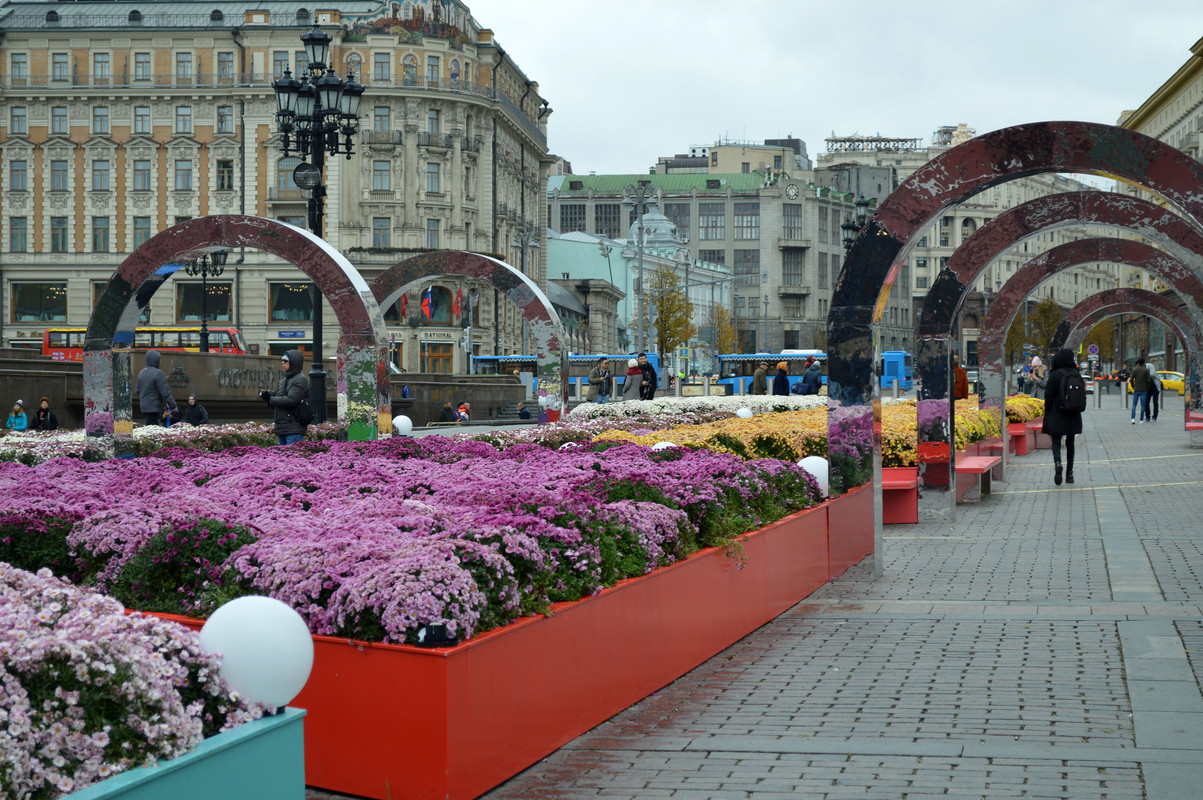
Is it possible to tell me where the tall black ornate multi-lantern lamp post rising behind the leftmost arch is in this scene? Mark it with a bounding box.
[273,25,363,422]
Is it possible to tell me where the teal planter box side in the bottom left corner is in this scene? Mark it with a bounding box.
[64,709,306,800]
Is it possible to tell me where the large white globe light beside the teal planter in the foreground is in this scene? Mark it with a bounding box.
[201,597,313,706]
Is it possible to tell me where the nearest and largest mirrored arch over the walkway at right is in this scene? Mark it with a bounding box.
[828,122,1203,538]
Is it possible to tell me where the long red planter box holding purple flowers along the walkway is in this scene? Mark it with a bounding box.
[157,486,873,800]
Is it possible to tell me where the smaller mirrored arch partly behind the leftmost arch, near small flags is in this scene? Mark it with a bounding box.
[372,250,568,410]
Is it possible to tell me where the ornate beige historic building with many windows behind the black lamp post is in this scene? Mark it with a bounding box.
[0,0,553,372]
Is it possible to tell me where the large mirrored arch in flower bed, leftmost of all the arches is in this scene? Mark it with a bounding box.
[83,214,391,455]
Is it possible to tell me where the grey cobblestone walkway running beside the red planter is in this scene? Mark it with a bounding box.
[469,395,1203,800]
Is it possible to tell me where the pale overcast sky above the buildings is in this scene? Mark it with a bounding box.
[466,0,1203,173]
